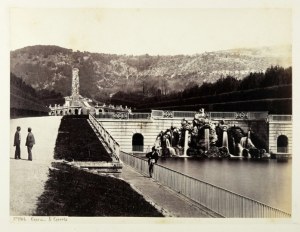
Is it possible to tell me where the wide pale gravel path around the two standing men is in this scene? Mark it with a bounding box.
[10,117,61,216]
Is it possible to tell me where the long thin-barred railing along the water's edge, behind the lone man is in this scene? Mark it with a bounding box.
[120,152,291,218]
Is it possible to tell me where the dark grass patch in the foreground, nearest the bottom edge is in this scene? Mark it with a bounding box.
[35,163,163,217]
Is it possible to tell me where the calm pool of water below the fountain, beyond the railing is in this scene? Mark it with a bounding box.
[158,158,292,212]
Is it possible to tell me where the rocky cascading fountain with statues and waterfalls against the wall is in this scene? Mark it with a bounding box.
[156,110,268,158]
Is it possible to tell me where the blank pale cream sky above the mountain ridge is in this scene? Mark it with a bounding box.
[9,7,292,55]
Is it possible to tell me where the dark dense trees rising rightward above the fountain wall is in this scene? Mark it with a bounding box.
[111,66,292,113]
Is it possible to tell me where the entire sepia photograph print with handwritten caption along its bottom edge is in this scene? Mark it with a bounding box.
[3,1,298,230]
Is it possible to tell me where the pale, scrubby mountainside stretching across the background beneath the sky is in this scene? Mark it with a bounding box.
[10,45,291,101]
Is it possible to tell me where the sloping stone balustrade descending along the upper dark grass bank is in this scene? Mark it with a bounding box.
[89,114,120,160]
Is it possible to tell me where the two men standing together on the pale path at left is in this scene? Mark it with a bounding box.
[14,126,35,161]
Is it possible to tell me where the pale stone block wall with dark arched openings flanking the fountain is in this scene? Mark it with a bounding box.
[98,115,292,153]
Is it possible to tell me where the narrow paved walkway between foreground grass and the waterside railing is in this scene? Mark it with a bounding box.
[121,165,217,218]
